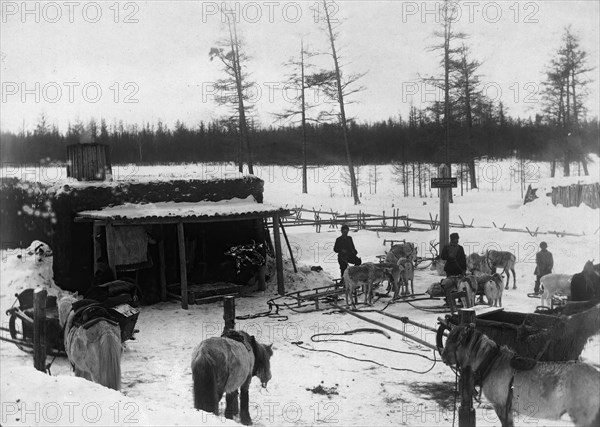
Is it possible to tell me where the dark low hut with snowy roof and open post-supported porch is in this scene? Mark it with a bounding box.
[2,170,289,307]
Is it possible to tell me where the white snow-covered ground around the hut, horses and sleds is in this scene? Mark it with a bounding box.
[0,158,600,426]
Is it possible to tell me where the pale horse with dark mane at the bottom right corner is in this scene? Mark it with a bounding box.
[441,325,600,427]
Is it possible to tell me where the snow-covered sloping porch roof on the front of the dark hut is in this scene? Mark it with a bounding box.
[77,196,289,221]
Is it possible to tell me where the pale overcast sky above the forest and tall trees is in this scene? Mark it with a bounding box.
[0,1,600,131]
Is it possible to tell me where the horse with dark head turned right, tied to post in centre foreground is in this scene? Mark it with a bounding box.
[192,331,273,425]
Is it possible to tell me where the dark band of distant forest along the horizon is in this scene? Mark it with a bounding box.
[0,111,600,164]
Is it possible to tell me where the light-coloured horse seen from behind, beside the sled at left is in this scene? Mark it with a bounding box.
[58,294,122,390]
